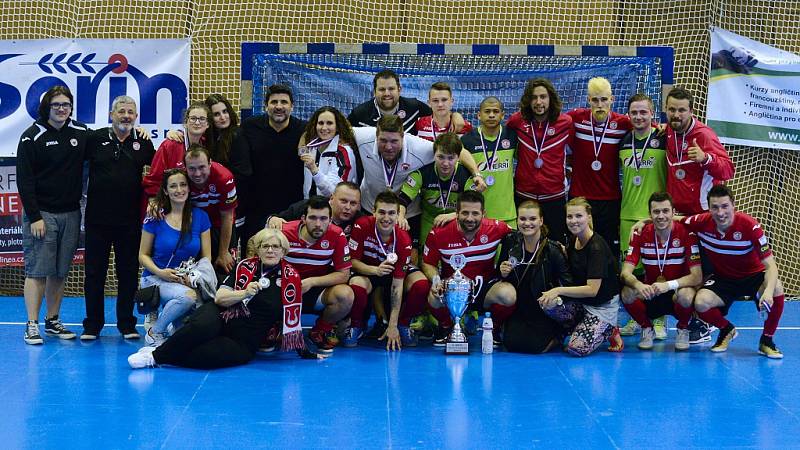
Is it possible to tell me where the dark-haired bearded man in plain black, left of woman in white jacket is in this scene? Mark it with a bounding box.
[234,84,306,246]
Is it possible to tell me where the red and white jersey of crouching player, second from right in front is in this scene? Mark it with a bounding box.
[625,222,700,284]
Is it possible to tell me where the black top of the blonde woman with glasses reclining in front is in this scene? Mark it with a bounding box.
[222,264,283,351]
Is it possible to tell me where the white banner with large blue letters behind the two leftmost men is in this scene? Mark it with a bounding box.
[0,39,191,157]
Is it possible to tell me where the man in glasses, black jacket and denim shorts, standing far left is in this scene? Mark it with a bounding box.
[17,86,87,344]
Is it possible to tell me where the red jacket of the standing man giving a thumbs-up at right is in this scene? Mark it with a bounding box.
[667,118,734,215]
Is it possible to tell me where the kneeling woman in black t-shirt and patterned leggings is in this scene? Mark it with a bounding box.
[539,197,624,356]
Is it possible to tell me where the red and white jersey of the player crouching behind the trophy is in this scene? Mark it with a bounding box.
[423,219,512,282]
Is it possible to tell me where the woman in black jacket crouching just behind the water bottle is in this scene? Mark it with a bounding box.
[498,200,572,353]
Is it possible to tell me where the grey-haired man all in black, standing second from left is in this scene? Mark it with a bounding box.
[80,95,155,341]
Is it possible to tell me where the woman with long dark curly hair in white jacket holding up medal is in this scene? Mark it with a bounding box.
[299,106,361,198]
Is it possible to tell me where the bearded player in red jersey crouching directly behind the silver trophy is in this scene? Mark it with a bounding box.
[422,191,516,346]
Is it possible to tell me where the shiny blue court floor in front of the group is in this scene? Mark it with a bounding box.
[0,297,800,449]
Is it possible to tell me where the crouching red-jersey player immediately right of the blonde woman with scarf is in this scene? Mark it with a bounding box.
[282,195,353,353]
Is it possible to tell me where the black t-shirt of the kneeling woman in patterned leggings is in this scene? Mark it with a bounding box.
[567,233,619,306]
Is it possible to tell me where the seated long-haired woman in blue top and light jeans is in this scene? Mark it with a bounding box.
[139,169,211,347]
